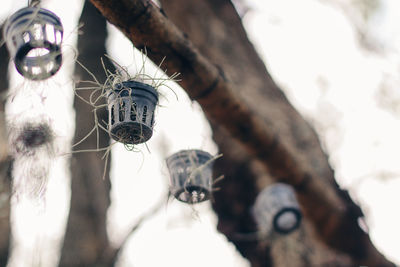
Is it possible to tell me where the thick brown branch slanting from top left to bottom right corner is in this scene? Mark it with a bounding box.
[91,0,394,266]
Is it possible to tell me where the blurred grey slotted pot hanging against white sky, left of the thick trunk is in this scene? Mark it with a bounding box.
[166,150,213,204]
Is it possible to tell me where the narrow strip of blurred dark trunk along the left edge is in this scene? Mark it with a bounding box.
[0,24,12,266]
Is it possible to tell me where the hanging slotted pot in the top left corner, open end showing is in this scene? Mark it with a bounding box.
[3,7,63,80]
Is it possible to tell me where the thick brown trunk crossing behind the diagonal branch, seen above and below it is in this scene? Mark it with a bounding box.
[161,0,351,266]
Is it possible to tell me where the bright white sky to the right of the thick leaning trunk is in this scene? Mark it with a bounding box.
[245,0,400,263]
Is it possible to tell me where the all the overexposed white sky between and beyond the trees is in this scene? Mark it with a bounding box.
[0,0,400,267]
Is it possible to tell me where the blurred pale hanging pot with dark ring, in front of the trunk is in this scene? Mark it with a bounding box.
[253,183,302,234]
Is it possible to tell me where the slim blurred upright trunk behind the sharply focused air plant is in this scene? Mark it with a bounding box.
[59,1,113,267]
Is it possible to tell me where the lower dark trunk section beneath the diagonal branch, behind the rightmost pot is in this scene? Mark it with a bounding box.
[212,124,354,267]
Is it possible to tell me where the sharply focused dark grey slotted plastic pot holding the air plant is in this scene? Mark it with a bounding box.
[108,81,158,145]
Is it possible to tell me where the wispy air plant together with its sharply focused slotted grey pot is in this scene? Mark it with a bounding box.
[73,52,179,178]
